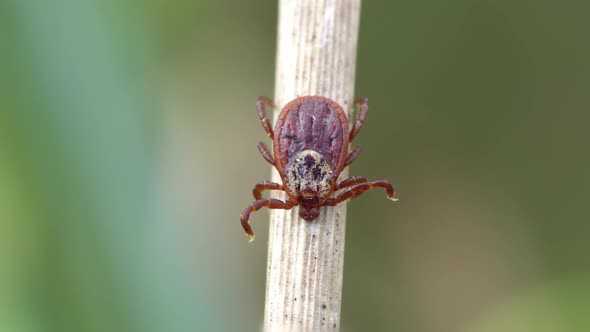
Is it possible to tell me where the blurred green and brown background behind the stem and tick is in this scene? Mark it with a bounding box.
[0,0,590,332]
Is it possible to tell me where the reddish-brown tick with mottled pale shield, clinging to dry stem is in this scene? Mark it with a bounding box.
[240,96,397,241]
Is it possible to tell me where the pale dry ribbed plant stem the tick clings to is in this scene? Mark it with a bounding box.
[264,0,360,331]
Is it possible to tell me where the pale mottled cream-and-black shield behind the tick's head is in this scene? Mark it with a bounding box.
[285,150,334,200]
